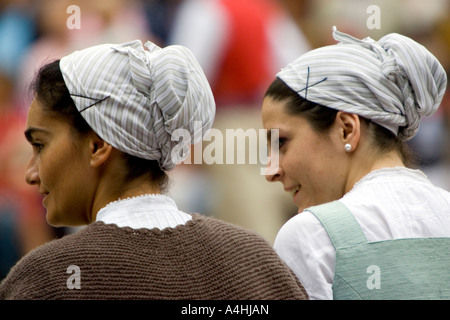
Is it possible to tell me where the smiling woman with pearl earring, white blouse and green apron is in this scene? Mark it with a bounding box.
[262,28,450,299]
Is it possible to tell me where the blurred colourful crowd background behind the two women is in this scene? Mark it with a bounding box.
[0,0,450,280]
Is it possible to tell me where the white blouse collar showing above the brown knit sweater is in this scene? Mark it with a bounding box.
[96,194,192,230]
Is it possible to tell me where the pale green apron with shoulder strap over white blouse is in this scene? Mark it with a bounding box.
[307,201,450,300]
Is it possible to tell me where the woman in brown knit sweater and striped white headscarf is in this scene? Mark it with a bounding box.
[0,41,307,299]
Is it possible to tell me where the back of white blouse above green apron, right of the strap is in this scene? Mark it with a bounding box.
[340,168,450,242]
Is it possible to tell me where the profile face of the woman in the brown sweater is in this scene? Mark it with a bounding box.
[25,99,92,226]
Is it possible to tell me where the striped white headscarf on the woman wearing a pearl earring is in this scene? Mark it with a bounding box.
[277,27,447,140]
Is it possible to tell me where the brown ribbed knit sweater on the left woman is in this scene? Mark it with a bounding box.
[0,215,307,300]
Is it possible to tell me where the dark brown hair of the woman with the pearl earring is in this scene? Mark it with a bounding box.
[264,78,417,167]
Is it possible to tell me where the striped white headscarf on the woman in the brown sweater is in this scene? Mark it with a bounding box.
[60,40,215,170]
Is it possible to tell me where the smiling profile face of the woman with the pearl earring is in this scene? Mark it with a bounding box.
[262,97,346,212]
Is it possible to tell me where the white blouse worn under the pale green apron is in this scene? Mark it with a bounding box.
[274,167,450,300]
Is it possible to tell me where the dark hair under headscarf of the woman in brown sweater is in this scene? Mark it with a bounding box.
[31,60,169,192]
